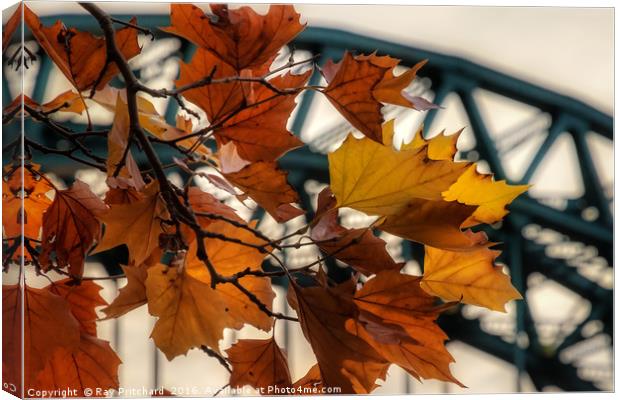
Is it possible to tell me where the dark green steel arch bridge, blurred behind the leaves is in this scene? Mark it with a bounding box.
[3,15,613,391]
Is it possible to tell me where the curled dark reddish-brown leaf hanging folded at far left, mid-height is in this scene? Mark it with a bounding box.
[39,180,107,278]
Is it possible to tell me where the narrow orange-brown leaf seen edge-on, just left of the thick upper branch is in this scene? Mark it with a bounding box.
[106,95,145,191]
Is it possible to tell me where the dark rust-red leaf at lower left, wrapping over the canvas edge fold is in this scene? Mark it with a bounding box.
[2,285,80,384]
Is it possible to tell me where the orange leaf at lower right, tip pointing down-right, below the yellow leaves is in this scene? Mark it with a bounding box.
[347,271,462,385]
